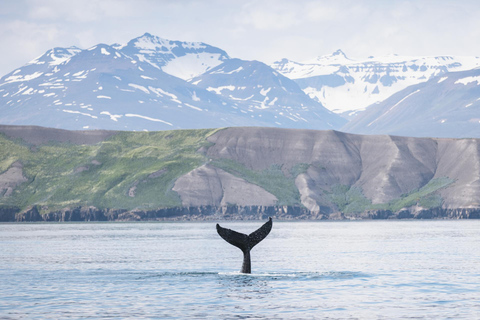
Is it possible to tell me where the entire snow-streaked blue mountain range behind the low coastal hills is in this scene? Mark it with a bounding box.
[0,33,480,137]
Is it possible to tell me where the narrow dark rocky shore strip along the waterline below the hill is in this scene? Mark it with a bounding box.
[0,206,480,222]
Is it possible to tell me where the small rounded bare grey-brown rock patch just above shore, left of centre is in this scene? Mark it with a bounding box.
[173,164,278,207]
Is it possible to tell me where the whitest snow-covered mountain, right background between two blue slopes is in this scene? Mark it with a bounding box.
[271,50,480,118]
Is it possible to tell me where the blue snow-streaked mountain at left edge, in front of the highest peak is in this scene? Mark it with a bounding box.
[0,44,247,130]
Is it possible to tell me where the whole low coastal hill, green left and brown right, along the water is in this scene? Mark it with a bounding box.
[0,126,480,221]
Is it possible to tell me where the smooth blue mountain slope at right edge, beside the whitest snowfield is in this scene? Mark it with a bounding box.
[342,69,480,138]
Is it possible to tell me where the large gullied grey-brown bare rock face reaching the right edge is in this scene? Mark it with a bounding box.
[206,128,480,212]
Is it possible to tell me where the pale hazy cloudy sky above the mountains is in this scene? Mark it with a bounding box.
[0,0,480,76]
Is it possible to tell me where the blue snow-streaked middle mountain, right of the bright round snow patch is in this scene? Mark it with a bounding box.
[191,59,345,128]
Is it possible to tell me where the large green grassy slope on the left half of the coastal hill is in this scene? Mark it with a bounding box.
[0,130,217,209]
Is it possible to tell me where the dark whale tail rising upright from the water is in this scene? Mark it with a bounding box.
[217,218,273,273]
